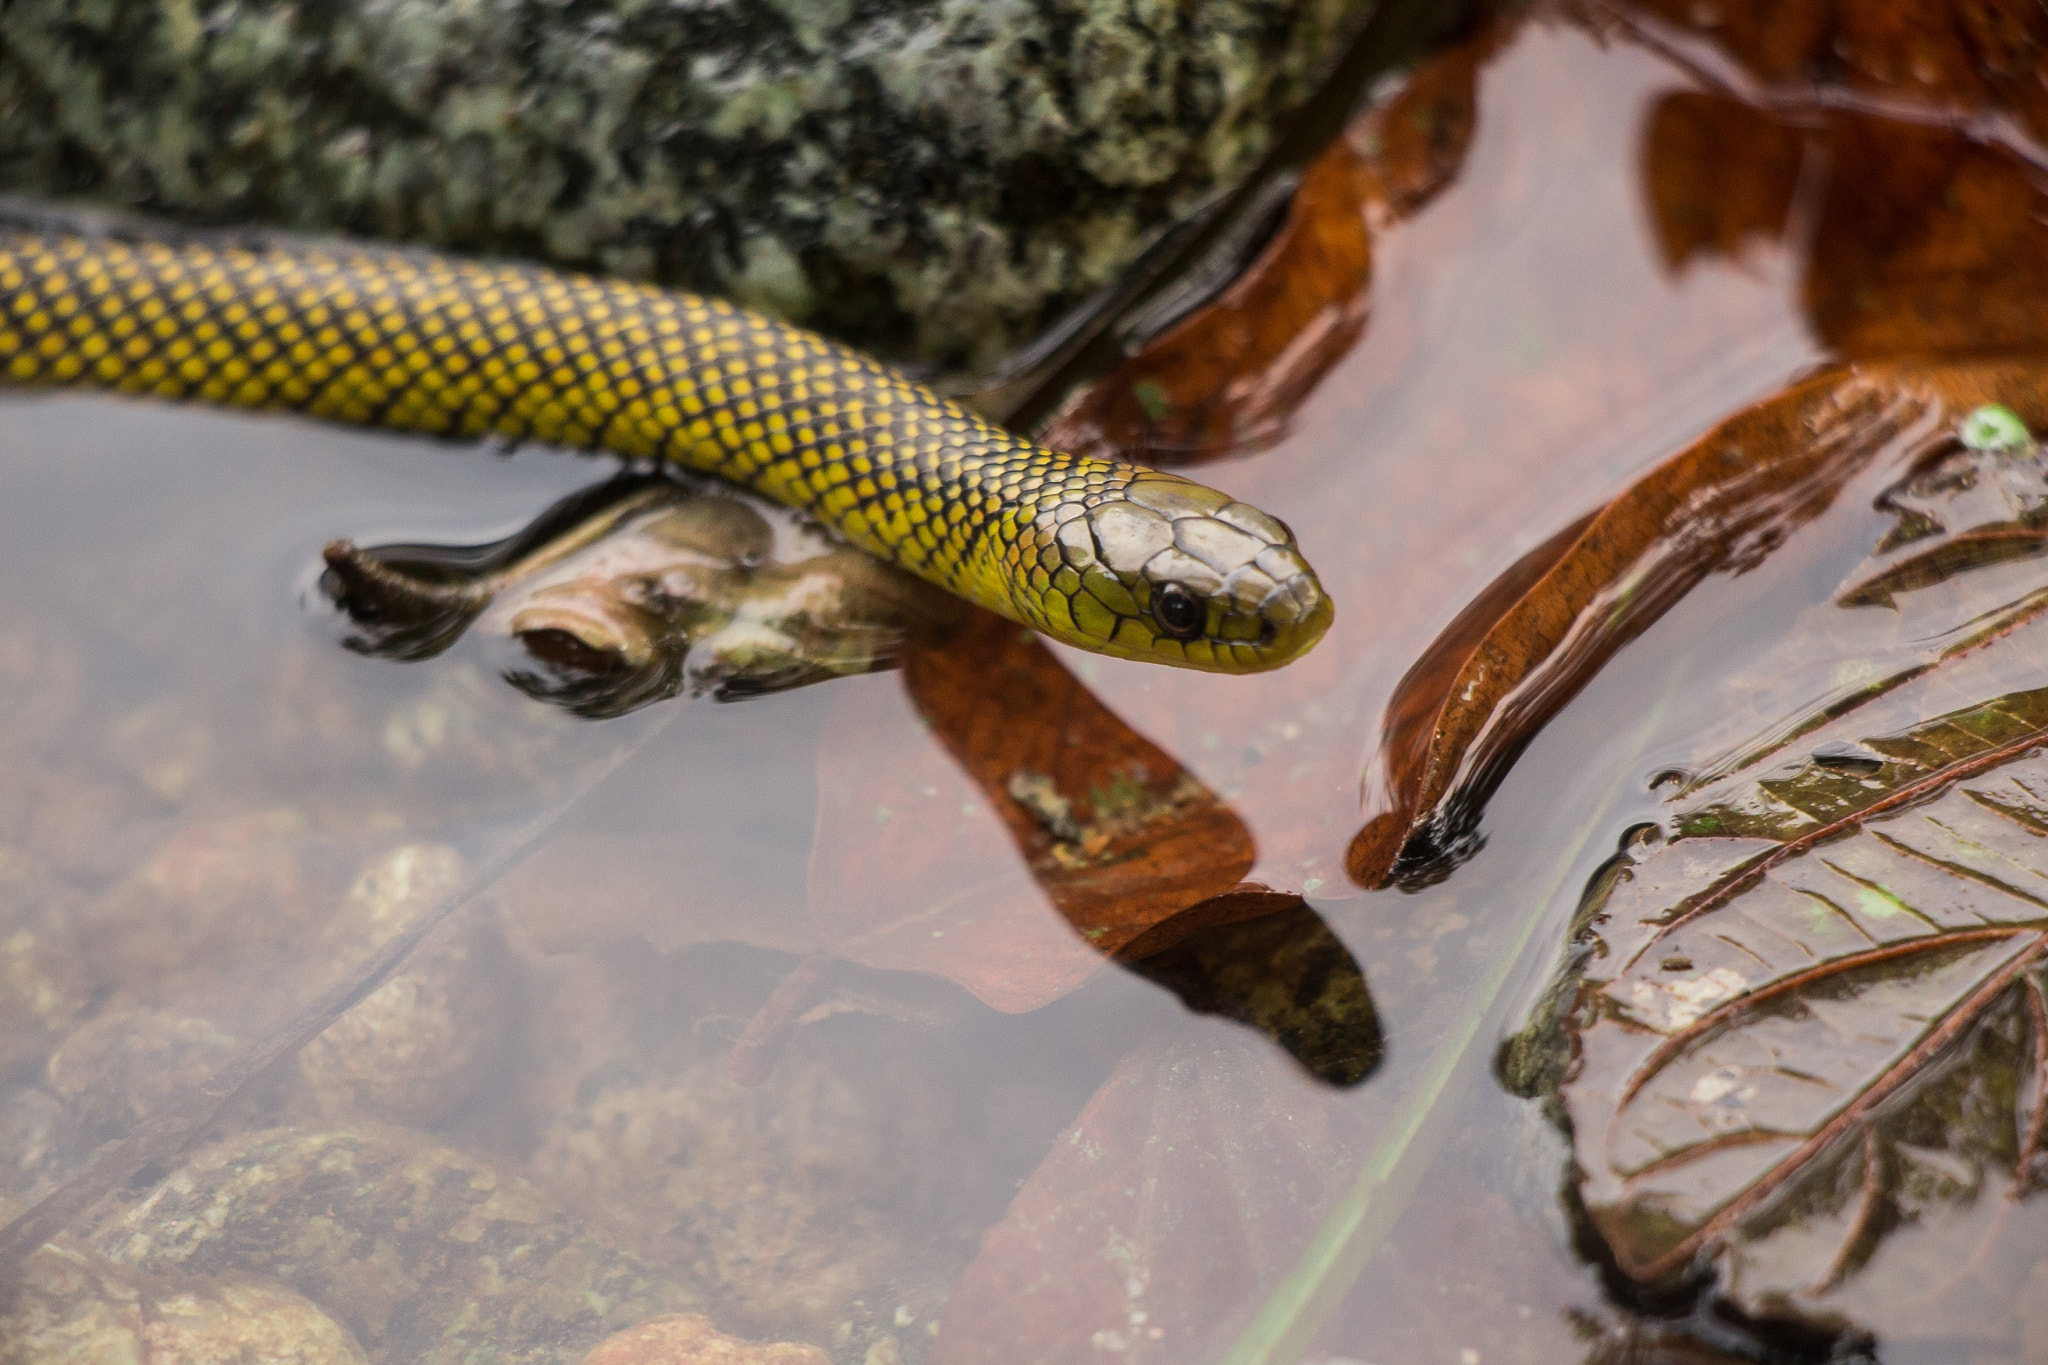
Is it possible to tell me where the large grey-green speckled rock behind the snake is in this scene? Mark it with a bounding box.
[0,0,1374,362]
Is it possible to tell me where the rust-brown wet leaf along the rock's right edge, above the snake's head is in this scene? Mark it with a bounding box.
[1042,27,1505,465]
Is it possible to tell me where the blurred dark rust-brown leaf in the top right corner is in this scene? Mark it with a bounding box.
[1642,92,2048,358]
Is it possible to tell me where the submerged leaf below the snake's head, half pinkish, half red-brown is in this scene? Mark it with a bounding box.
[811,614,1298,1011]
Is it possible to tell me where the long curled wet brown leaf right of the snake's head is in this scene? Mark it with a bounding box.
[1348,362,2048,886]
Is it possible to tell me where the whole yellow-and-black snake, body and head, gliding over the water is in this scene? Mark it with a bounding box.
[0,217,1333,673]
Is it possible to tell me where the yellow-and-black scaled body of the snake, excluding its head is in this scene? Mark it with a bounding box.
[0,225,1138,655]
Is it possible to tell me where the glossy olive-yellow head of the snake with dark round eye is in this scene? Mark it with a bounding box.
[1032,471,1331,673]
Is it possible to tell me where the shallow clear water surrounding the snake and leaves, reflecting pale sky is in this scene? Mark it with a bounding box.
[0,10,2034,1365]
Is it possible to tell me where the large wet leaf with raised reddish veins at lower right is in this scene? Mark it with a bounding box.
[1523,620,2048,1308]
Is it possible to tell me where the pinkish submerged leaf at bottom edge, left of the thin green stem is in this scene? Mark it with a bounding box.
[932,1033,1356,1365]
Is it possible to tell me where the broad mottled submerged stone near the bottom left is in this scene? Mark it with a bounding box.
[92,1130,702,1365]
